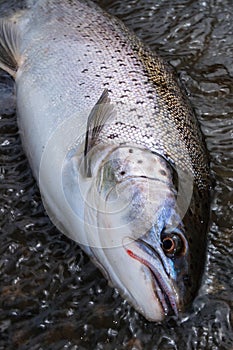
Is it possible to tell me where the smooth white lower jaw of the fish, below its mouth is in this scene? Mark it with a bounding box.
[92,243,166,322]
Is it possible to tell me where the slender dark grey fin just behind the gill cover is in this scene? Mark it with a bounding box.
[84,89,115,177]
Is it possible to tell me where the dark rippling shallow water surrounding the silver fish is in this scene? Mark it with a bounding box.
[0,0,233,350]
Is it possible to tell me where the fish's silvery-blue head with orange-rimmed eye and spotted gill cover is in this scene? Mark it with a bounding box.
[85,146,208,321]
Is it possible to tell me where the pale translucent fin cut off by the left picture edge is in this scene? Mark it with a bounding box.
[0,18,20,77]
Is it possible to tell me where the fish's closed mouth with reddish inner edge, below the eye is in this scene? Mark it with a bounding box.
[124,239,179,316]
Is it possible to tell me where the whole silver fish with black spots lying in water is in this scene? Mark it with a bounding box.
[0,0,211,322]
